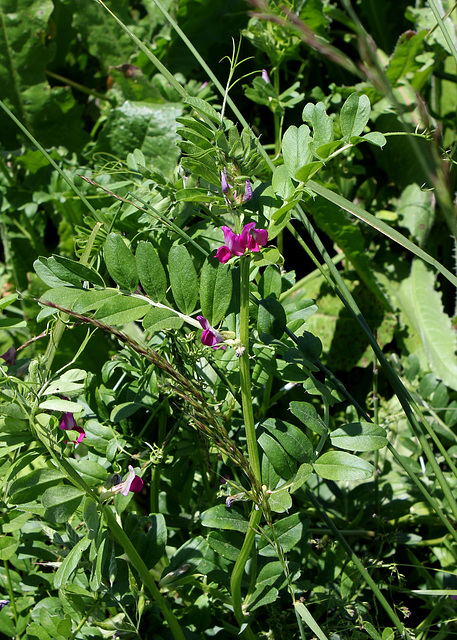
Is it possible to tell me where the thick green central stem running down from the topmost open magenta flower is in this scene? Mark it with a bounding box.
[230,255,262,640]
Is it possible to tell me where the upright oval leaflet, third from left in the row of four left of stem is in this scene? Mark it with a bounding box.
[168,244,198,315]
